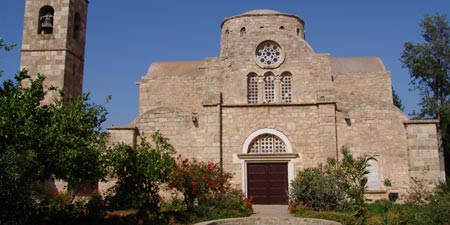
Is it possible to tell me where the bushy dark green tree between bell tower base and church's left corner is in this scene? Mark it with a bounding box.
[44,94,108,190]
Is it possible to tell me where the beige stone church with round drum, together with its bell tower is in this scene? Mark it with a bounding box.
[21,0,443,204]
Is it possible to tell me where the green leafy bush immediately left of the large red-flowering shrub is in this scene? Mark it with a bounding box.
[108,131,175,210]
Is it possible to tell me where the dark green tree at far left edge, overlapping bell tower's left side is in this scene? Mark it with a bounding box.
[0,71,48,224]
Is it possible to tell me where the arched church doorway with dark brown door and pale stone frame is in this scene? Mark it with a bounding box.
[239,129,298,204]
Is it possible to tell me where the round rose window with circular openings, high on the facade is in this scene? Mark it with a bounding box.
[256,41,283,68]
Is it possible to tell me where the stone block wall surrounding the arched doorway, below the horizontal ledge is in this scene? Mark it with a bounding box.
[223,105,335,187]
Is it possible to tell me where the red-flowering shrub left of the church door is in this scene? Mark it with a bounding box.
[169,155,231,210]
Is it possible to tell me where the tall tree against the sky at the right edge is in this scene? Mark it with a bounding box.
[401,15,450,174]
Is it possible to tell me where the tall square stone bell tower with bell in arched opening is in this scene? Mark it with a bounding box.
[20,0,89,104]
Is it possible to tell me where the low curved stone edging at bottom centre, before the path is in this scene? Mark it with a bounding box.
[195,217,342,225]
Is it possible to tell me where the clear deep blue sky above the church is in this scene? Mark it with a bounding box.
[0,0,450,126]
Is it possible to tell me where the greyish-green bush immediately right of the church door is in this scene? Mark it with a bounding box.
[289,149,369,224]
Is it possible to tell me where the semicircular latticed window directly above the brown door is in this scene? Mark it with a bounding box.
[248,133,286,154]
